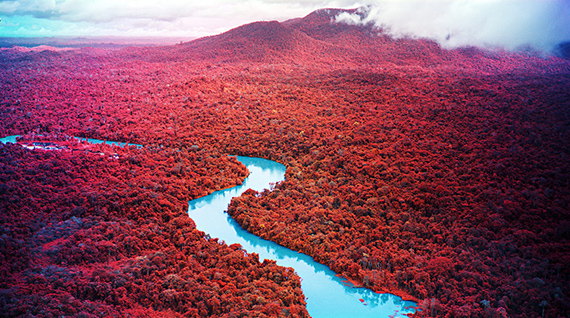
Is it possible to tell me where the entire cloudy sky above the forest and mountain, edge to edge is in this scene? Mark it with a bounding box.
[0,0,570,50]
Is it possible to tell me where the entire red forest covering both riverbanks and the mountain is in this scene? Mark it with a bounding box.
[0,10,570,317]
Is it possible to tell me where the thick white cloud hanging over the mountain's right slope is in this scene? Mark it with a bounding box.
[336,0,570,50]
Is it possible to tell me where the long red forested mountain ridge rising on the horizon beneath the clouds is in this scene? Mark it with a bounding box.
[134,9,564,69]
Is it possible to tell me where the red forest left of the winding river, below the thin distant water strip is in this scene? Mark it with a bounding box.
[0,141,308,317]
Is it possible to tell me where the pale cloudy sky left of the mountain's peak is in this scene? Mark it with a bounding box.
[0,0,360,37]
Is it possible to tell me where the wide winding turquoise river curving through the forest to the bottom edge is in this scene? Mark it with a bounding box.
[188,156,416,318]
